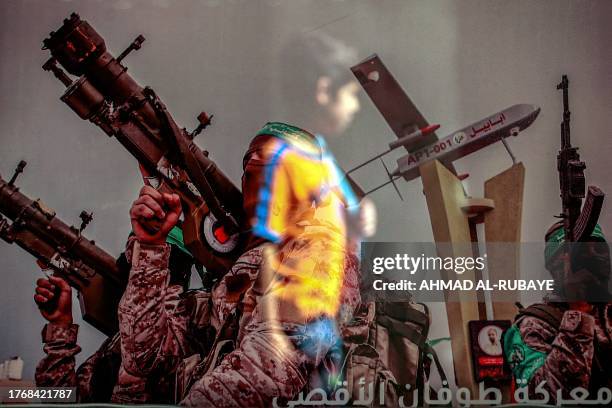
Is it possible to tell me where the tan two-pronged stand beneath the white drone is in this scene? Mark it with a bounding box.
[419,161,525,396]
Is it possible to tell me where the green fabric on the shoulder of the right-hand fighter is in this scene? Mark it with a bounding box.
[503,324,547,384]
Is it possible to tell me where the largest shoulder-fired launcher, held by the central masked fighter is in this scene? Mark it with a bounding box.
[43,13,248,273]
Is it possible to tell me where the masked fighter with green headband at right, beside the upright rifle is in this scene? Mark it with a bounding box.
[504,223,612,403]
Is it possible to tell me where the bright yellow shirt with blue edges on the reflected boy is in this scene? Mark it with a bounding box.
[247,124,356,321]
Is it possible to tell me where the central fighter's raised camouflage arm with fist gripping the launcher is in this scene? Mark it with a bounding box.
[119,186,188,376]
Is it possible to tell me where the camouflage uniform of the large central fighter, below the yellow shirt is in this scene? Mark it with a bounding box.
[119,237,360,407]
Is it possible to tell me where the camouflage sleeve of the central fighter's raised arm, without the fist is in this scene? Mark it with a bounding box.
[118,241,188,377]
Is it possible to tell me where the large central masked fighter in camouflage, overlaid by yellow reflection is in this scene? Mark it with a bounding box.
[115,31,371,406]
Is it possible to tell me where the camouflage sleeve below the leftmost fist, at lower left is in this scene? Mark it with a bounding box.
[34,323,81,387]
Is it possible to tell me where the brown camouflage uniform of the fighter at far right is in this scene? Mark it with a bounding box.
[506,303,612,403]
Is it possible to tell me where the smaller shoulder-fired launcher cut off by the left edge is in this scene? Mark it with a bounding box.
[0,161,128,336]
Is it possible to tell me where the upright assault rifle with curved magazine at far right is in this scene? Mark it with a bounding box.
[557,75,604,242]
